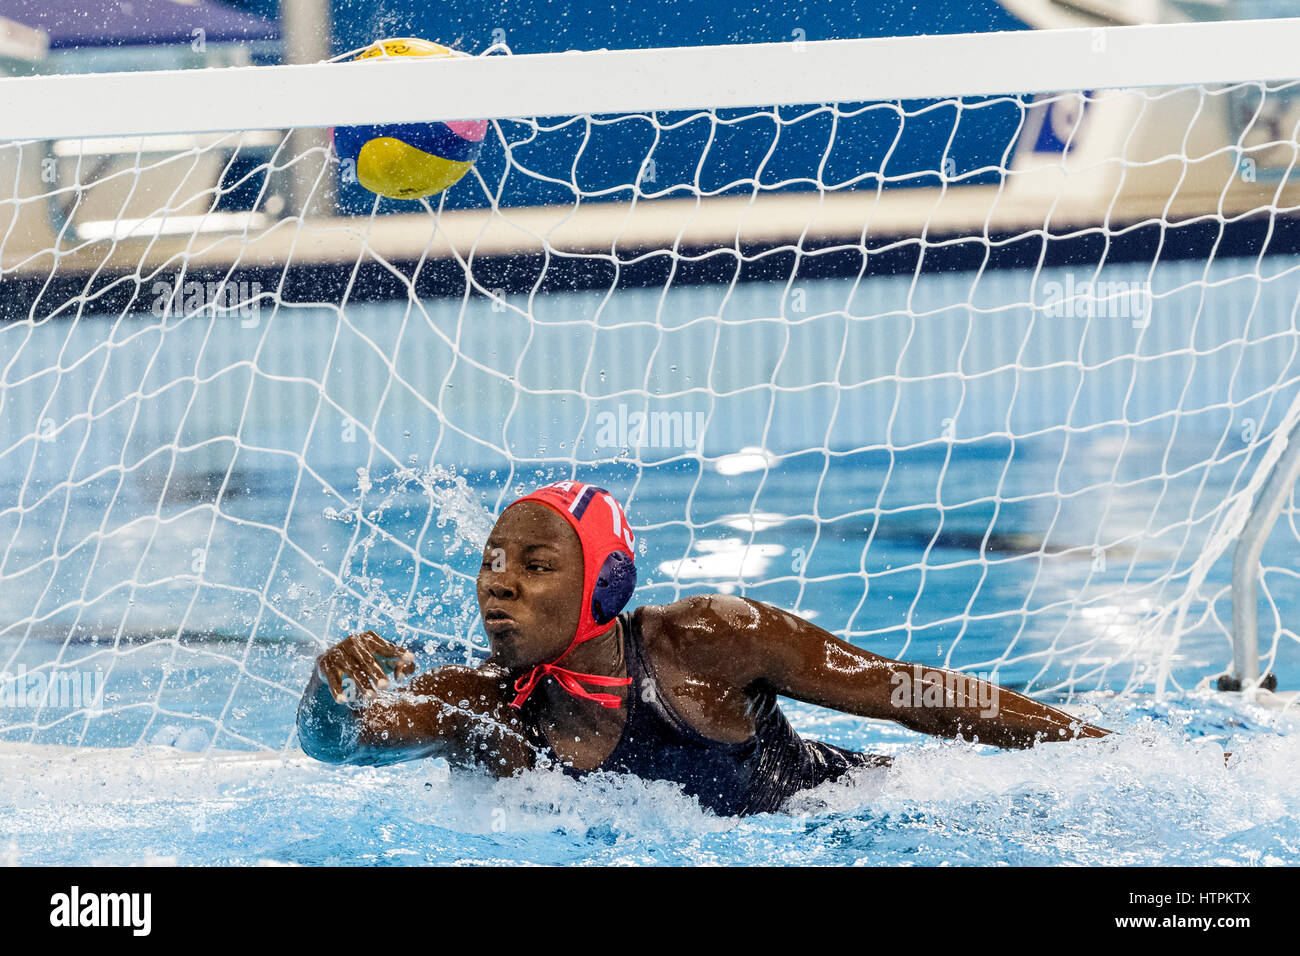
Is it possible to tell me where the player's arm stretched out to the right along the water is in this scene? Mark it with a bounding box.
[664,594,1110,748]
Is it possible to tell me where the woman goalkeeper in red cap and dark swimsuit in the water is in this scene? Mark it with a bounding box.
[298,481,1109,814]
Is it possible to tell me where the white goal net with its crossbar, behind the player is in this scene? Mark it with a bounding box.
[0,21,1300,749]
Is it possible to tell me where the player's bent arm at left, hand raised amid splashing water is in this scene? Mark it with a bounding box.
[298,631,536,775]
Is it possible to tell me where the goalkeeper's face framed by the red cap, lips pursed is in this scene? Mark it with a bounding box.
[478,501,582,670]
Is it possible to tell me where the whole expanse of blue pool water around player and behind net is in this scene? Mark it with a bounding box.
[0,260,1300,865]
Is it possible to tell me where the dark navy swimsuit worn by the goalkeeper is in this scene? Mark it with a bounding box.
[521,611,888,816]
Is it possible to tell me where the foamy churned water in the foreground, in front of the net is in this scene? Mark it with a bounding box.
[0,696,1300,865]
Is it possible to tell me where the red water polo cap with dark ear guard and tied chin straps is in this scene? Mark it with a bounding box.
[507,481,637,708]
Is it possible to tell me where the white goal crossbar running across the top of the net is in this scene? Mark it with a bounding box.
[0,17,1300,140]
